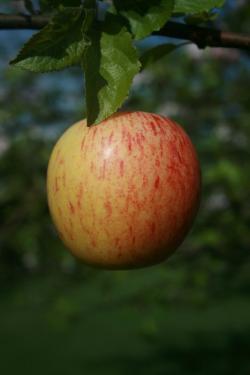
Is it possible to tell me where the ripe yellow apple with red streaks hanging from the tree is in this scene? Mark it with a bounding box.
[47,112,201,269]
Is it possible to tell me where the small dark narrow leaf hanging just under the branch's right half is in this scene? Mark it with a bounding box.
[140,43,180,70]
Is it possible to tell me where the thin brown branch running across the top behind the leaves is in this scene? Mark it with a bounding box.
[0,14,250,51]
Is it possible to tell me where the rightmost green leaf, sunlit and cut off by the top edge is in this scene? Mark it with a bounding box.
[174,0,225,14]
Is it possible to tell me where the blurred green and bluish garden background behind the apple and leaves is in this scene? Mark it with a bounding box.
[0,1,250,375]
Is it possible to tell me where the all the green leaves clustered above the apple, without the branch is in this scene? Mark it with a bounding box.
[9,0,224,125]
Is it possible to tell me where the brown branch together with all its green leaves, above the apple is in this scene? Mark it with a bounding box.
[0,0,250,125]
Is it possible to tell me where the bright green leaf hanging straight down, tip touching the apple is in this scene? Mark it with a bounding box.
[83,14,140,125]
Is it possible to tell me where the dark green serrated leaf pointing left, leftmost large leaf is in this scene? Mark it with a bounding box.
[11,8,91,73]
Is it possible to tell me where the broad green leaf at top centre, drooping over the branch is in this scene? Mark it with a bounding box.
[113,0,174,39]
